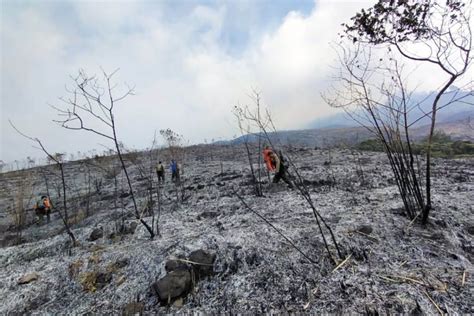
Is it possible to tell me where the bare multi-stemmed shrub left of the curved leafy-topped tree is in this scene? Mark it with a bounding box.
[323,45,465,223]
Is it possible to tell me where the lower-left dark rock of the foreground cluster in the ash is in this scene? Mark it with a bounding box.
[152,270,192,304]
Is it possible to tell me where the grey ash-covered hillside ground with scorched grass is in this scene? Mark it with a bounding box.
[0,146,474,314]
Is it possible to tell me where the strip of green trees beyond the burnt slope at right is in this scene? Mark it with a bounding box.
[356,132,474,158]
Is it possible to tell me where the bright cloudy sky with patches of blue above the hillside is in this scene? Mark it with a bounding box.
[0,0,470,161]
